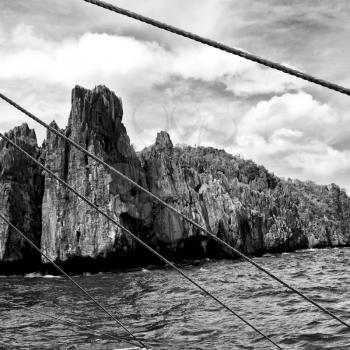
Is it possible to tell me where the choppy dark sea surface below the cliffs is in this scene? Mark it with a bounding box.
[0,248,350,350]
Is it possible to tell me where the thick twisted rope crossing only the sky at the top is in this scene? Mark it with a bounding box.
[83,0,350,96]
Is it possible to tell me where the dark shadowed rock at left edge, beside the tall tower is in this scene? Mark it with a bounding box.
[0,124,43,272]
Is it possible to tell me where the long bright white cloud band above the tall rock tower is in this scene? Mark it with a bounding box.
[0,25,301,95]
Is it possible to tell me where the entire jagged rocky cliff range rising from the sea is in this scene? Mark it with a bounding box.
[0,86,350,270]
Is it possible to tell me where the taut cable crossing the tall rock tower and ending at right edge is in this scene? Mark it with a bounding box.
[0,93,350,328]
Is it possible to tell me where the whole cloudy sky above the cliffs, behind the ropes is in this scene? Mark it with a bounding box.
[0,0,350,191]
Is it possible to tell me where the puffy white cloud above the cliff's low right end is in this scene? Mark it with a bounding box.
[230,92,350,189]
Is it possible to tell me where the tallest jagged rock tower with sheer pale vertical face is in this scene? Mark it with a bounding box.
[42,86,151,268]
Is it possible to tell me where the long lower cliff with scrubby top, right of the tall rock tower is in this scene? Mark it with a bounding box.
[140,132,350,256]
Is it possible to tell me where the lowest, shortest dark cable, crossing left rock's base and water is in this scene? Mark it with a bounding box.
[0,212,147,348]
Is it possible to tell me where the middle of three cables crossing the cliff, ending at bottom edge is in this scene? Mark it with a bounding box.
[0,132,282,349]
